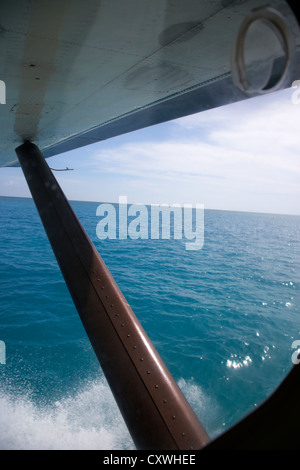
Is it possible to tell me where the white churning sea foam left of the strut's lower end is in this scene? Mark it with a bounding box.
[0,379,135,450]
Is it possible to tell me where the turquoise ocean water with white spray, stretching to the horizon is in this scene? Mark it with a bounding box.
[0,197,300,450]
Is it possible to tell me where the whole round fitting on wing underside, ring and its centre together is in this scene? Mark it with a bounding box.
[231,7,294,95]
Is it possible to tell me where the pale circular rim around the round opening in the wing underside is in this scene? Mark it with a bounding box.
[231,7,294,95]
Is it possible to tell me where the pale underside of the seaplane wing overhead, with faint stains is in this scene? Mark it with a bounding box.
[0,0,300,166]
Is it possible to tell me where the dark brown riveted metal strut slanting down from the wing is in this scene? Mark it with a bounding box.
[16,142,209,450]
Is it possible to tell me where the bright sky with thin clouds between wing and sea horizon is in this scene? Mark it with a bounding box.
[0,88,300,215]
